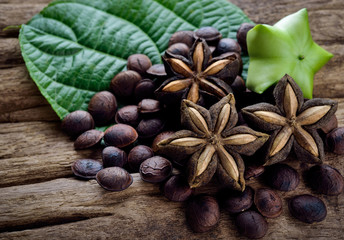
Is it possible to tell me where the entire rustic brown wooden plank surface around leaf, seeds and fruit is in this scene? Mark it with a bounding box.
[0,0,344,239]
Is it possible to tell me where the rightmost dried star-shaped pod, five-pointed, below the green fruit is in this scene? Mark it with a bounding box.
[242,75,338,165]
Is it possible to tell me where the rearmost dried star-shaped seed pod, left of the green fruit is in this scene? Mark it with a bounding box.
[156,38,240,104]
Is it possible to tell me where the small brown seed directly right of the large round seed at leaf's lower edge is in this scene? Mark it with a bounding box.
[115,105,141,127]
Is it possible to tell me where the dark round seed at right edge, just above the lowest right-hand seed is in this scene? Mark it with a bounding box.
[306,164,344,195]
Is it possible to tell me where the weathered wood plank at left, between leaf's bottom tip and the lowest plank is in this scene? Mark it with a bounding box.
[0,122,101,187]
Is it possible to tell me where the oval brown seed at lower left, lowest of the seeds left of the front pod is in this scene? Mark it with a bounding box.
[96,167,133,191]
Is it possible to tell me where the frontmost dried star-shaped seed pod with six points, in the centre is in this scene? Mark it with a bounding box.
[158,94,269,191]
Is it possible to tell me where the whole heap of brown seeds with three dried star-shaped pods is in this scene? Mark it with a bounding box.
[62,24,344,238]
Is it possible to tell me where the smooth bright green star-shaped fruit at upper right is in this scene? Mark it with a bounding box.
[246,8,333,98]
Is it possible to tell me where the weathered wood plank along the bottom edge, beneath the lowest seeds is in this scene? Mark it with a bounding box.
[0,168,344,239]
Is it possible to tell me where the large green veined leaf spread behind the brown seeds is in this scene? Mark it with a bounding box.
[19,0,251,119]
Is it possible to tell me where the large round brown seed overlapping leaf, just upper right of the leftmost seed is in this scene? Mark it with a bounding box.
[88,91,117,125]
